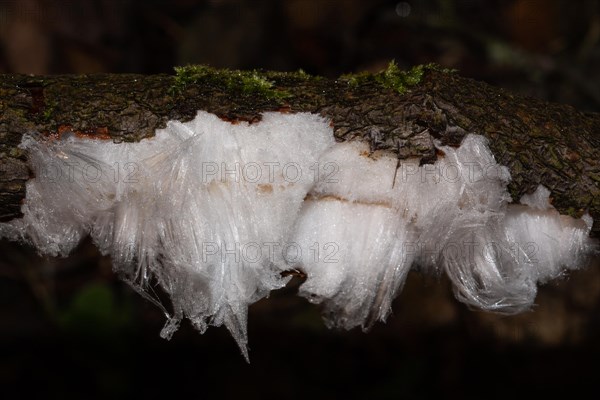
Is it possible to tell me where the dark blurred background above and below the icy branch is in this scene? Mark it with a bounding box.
[0,0,600,399]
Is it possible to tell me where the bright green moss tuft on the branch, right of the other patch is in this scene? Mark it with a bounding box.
[340,61,455,94]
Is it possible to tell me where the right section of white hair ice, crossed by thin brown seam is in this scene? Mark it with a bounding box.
[296,135,595,318]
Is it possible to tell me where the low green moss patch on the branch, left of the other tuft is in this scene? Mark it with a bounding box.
[172,65,290,100]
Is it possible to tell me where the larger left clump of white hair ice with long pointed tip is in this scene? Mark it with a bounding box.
[0,112,333,360]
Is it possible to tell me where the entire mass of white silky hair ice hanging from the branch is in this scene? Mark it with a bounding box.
[0,112,596,357]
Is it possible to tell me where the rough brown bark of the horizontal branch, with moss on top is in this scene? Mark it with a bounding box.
[0,64,600,237]
